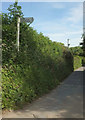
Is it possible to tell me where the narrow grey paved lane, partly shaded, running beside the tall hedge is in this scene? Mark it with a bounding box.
[3,67,84,118]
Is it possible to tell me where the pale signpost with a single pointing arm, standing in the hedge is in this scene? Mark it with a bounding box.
[17,15,34,51]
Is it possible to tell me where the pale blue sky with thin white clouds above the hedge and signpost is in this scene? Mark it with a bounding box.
[2,2,83,46]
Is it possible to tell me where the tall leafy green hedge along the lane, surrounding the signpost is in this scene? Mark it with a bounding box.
[2,3,73,109]
